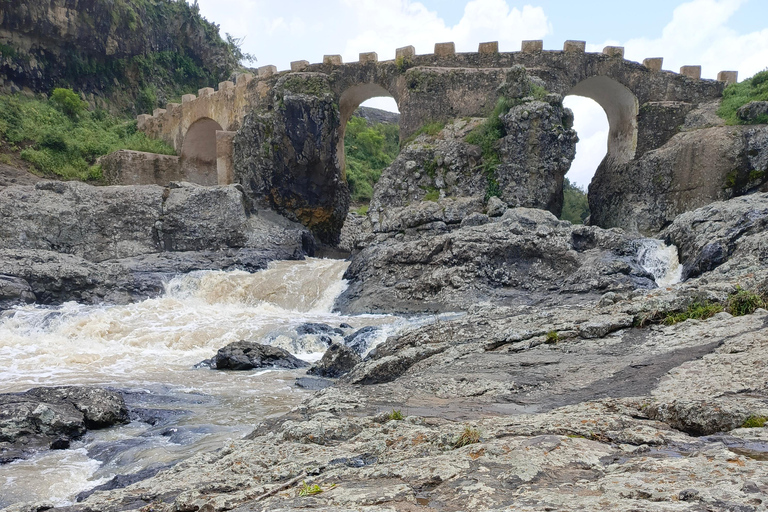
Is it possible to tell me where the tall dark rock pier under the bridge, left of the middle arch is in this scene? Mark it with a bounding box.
[233,73,349,245]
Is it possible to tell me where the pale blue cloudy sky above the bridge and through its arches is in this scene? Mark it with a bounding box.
[198,0,768,187]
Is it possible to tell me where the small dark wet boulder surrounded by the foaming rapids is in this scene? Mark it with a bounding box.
[210,340,309,370]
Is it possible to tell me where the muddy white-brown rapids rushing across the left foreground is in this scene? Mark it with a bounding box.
[0,259,404,508]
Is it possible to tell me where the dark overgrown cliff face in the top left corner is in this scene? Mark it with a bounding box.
[0,0,238,110]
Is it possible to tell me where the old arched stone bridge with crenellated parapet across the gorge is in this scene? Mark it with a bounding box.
[138,41,737,242]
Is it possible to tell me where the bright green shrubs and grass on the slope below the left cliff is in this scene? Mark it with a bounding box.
[0,89,174,180]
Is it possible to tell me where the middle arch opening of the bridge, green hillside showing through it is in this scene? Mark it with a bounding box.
[336,83,399,204]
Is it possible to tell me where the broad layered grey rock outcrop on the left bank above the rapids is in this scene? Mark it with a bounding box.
[0,182,314,307]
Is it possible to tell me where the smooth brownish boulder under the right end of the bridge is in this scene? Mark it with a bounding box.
[589,126,768,235]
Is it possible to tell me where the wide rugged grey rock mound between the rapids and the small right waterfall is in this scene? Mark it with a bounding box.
[336,208,656,313]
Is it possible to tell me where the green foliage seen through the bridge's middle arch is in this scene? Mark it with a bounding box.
[344,117,400,203]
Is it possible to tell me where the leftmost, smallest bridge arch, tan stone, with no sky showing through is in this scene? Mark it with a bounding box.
[181,117,223,185]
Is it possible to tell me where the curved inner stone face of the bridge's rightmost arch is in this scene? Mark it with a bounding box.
[566,76,640,164]
